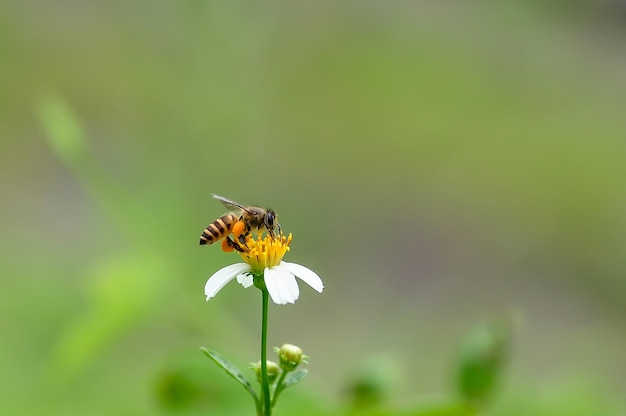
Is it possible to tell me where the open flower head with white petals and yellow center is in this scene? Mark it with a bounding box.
[204,234,324,305]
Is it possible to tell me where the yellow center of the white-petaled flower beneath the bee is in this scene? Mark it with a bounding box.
[239,233,292,274]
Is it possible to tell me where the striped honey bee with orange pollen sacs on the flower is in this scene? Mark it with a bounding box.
[200,194,280,251]
